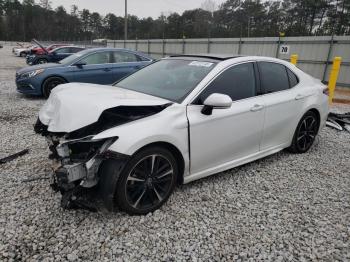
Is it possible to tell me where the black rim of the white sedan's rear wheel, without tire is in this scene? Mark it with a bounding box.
[297,116,318,151]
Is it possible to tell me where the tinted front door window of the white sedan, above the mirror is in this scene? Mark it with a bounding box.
[195,63,256,104]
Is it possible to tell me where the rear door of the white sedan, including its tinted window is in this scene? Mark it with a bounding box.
[258,62,303,150]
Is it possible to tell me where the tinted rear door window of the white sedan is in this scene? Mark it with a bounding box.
[258,62,289,94]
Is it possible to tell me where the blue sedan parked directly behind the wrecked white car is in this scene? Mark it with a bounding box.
[16,48,153,97]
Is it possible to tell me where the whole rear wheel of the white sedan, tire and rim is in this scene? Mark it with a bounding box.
[288,111,320,154]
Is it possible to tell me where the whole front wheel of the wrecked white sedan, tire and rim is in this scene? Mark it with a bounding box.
[100,147,179,215]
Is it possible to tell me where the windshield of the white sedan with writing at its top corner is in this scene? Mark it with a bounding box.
[114,59,216,103]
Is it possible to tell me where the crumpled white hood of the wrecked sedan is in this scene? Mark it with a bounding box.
[39,83,171,133]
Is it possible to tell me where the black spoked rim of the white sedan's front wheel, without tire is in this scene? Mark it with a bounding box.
[125,154,174,210]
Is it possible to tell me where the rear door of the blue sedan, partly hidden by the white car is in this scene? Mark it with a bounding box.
[112,51,150,82]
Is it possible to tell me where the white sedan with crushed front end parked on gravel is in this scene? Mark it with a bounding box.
[35,55,329,214]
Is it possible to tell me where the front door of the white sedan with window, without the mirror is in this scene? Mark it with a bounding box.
[187,62,265,174]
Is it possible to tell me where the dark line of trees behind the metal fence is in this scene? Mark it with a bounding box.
[0,0,350,41]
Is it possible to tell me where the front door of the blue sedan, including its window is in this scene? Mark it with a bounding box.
[69,51,113,85]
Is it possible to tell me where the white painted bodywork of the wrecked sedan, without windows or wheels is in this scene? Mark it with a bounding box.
[39,56,329,183]
